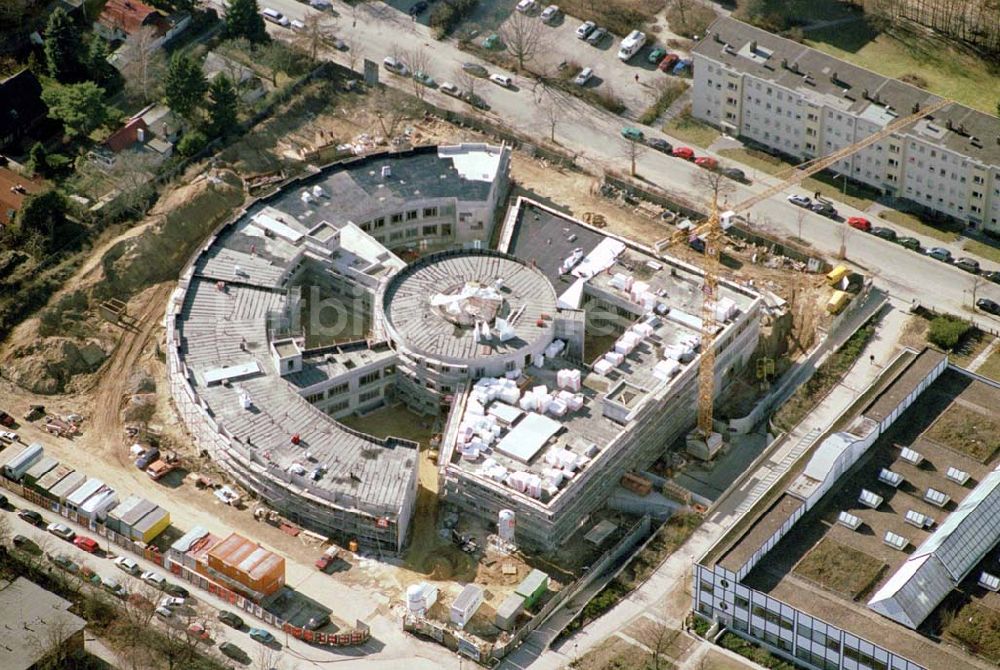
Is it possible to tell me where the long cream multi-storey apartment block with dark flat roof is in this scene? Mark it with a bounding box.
[691,18,1000,233]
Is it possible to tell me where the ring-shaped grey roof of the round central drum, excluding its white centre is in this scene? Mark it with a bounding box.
[382,250,556,363]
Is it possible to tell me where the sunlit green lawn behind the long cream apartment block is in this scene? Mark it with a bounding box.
[806,20,1000,114]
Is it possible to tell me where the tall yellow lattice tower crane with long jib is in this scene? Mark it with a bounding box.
[655,98,951,454]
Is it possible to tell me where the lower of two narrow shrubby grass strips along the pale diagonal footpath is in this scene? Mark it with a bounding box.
[563,512,702,634]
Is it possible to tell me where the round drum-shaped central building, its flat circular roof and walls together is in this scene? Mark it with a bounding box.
[377,249,558,413]
